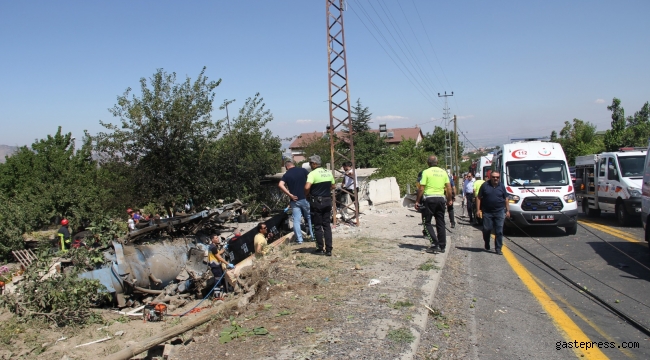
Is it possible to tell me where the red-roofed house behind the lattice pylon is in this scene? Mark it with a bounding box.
[289,124,424,162]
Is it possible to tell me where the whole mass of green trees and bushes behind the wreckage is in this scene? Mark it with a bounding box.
[0,68,282,261]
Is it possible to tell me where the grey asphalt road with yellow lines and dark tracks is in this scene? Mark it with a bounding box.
[459,207,650,359]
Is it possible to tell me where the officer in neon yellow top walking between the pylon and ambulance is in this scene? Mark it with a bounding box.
[415,155,453,254]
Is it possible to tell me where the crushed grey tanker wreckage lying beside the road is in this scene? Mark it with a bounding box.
[79,201,290,307]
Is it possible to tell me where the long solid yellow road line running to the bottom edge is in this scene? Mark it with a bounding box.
[501,246,608,359]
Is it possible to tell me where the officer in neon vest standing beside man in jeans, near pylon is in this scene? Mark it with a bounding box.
[305,155,336,256]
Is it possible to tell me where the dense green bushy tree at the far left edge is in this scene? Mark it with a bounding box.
[0,127,111,257]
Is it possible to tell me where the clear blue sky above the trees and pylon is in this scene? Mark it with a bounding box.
[0,0,650,146]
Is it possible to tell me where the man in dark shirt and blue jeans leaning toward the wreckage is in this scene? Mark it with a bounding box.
[278,161,314,244]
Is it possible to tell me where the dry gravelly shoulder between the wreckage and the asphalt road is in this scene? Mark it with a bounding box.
[174,207,469,359]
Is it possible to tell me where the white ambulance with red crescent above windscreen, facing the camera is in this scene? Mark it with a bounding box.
[486,139,578,235]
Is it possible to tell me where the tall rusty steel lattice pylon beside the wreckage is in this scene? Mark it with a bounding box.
[324,0,359,226]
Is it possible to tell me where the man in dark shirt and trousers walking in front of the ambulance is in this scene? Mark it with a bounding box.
[476,171,510,255]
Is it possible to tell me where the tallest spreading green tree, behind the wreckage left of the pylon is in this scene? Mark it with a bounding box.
[95,67,221,208]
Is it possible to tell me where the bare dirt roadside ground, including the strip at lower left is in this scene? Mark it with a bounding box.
[0,206,472,359]
